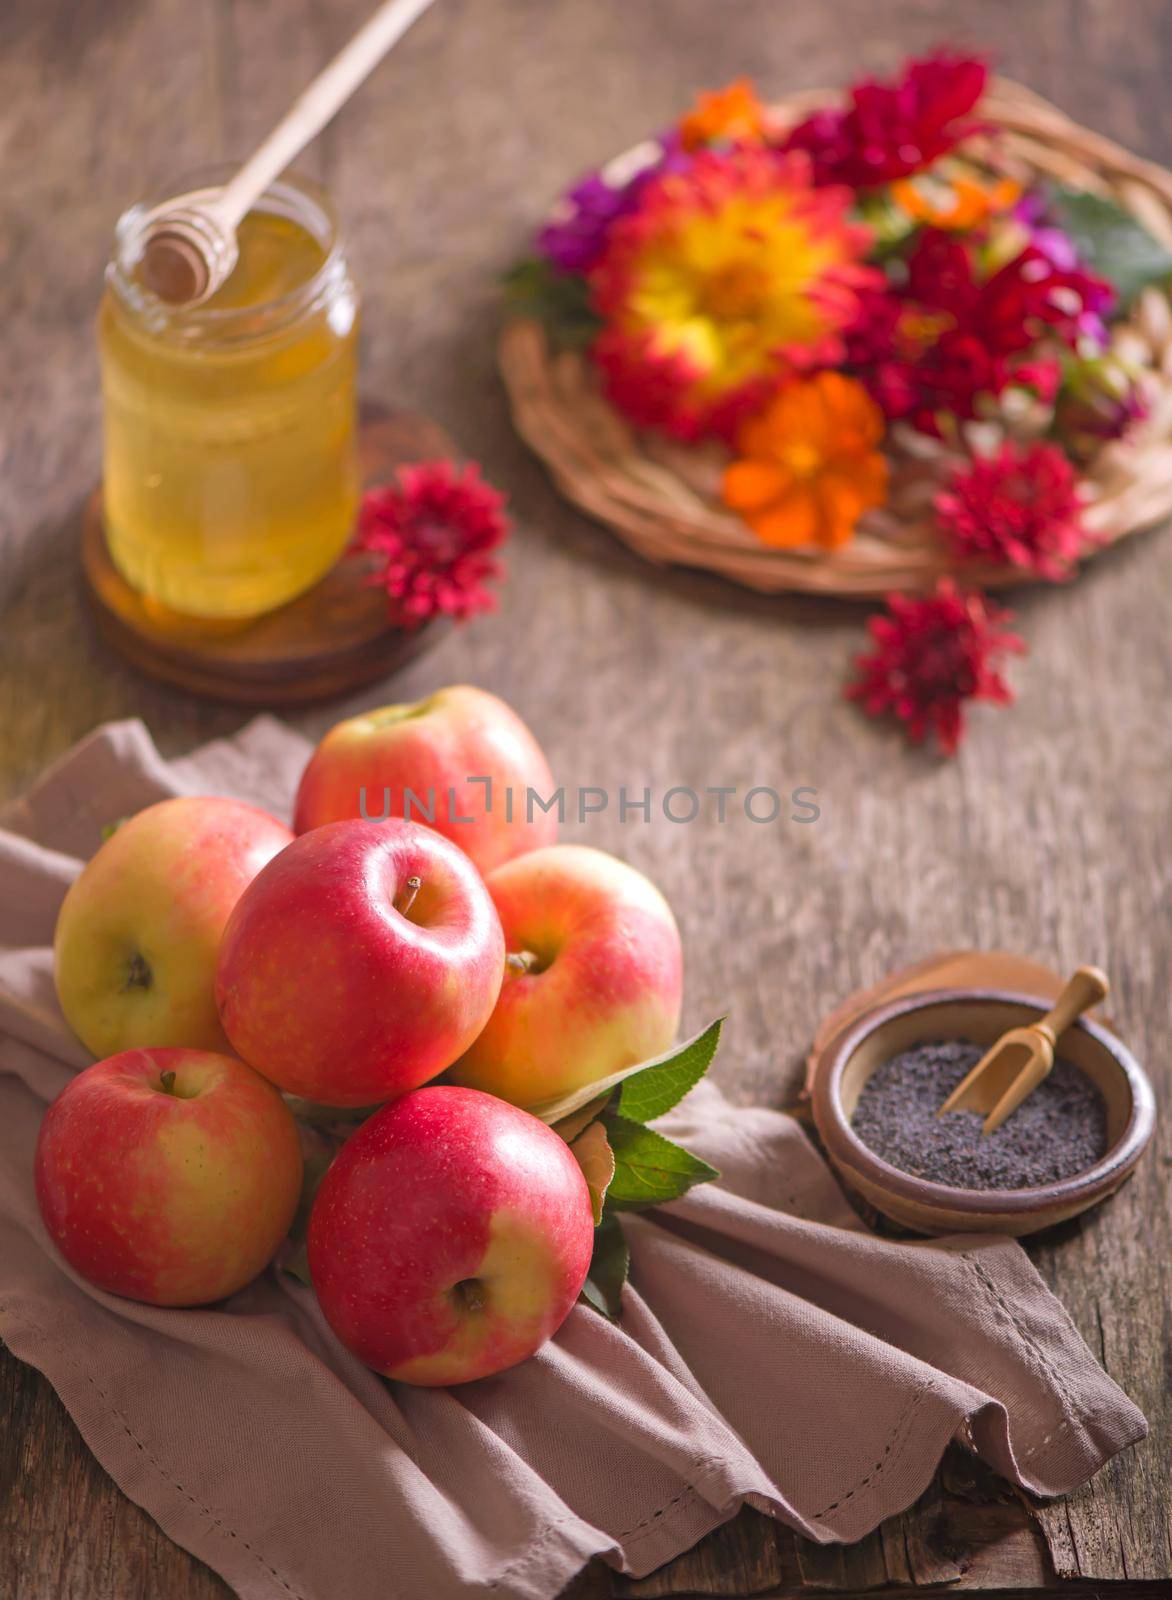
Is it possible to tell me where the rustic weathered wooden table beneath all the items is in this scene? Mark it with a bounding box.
[0,0,1172,1600]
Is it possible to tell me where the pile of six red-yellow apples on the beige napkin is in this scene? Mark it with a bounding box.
[35,688,680,1384]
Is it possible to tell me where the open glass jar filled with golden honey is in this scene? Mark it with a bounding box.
[98,170,359,619]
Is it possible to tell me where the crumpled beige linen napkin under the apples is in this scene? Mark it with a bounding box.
[0,718,1145,1600]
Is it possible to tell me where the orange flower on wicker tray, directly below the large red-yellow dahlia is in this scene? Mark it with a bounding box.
[724,373,887,550]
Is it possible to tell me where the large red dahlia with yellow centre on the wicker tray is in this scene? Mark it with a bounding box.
[591,147,882,438]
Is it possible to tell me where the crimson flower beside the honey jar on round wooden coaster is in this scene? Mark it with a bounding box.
[354,461,509,629]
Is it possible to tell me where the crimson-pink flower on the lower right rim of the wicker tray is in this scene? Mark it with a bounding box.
[935,442,1087,579]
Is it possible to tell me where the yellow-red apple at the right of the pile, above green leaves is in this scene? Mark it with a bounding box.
[453,845,682,1106]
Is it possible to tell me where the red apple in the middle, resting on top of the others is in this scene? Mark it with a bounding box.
[216,821,504,1106]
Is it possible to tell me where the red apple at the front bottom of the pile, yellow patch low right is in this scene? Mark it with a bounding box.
[309,1085,594,1384]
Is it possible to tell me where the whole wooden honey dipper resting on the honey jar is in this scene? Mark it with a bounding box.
[139,0,431,306]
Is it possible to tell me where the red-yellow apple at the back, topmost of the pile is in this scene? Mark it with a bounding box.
[293,685,557,872]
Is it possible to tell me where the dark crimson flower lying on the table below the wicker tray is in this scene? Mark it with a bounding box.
[845,578,1025,755]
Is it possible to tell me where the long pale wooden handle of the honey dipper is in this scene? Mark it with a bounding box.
[208,0,431,229]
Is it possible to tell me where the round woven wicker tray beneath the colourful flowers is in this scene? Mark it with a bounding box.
[498,80,1172,598]
